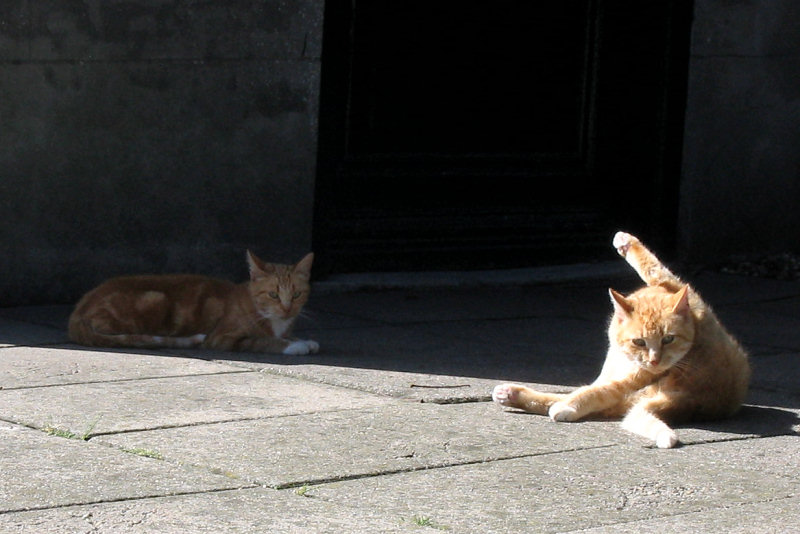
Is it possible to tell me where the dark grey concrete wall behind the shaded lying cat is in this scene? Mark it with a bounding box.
[0,0,323,306]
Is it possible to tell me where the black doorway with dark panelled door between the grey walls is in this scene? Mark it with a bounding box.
[314,0,691,272]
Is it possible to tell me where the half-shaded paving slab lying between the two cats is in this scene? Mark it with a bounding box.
[194,318,606,402]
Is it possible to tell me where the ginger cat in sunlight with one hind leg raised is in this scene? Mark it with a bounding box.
[492,232,750,448]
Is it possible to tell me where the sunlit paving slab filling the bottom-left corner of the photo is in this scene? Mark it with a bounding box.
[0,488,412,534]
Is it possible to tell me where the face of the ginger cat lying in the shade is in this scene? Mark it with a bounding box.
[247,251,314,320]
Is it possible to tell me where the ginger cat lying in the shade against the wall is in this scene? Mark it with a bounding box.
[69,251,319,354]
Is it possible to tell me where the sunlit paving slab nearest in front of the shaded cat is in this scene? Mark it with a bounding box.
[0,372,388,435]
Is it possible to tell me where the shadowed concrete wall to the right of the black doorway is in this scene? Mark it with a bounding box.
[679,0,800,262]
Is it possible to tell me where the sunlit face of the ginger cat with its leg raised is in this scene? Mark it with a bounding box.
[609,287,695,373]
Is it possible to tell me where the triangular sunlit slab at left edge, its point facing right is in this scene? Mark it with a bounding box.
[0,423,246,517]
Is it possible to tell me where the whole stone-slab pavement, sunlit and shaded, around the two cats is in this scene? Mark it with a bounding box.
[0,271,800,534]
